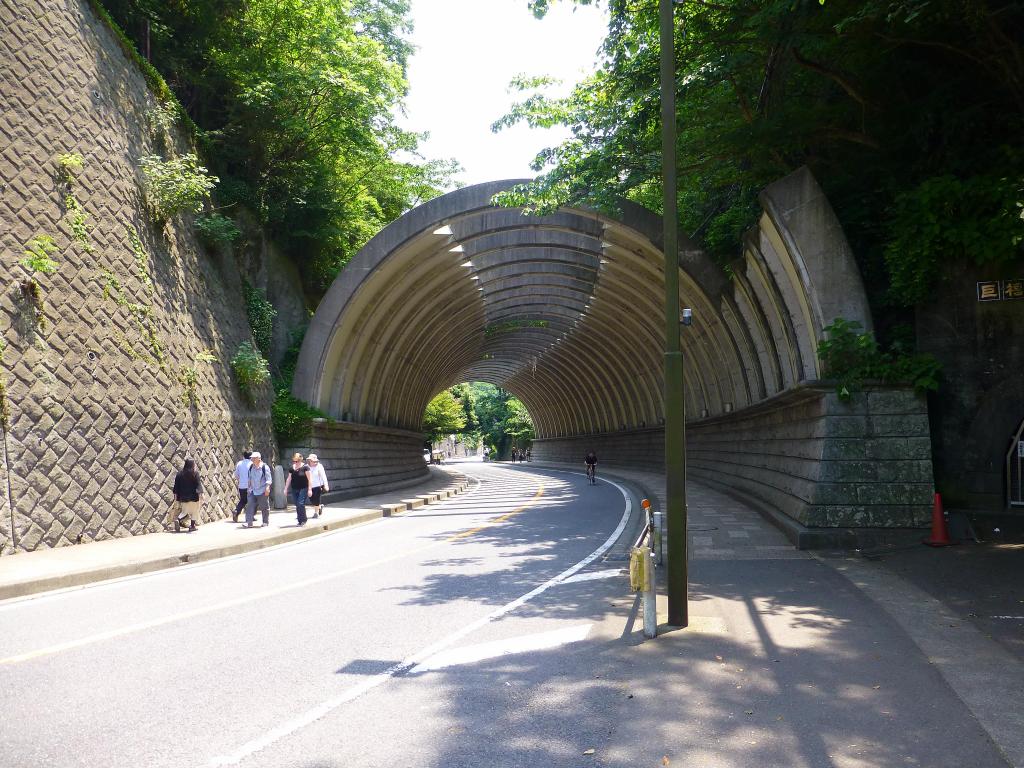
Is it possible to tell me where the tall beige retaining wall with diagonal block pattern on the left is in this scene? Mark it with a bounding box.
[0,0,274,554]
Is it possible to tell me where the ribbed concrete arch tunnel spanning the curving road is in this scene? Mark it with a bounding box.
[293,169,930,540]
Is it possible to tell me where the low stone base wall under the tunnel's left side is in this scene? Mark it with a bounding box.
[286,420,430,501]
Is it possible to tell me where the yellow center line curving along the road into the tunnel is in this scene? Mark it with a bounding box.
[0,484,544,666]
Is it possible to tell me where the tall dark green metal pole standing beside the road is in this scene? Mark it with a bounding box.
[659,0,689,627]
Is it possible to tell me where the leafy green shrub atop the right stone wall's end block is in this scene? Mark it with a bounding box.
[818,317,942,400]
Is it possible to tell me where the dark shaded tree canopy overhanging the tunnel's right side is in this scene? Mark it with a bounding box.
[494,0,1024,325]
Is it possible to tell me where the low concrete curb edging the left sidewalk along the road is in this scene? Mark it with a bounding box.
[0,474,470,600]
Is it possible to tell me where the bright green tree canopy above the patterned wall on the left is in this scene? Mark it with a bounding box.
[103,0,456,301]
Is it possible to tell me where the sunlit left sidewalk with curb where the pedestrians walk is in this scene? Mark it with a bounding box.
[0,467,470,600]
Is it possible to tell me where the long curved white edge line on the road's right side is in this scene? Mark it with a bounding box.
[207,472,633,766]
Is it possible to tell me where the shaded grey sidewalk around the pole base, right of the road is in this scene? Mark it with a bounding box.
[526,462,1024,768]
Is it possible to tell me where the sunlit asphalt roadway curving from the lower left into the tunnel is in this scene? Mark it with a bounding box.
[0,464,635,768]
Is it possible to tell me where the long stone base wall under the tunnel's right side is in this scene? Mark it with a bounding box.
[534,386,934,527]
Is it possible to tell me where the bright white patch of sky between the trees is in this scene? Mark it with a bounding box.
[399,0,607,184]
